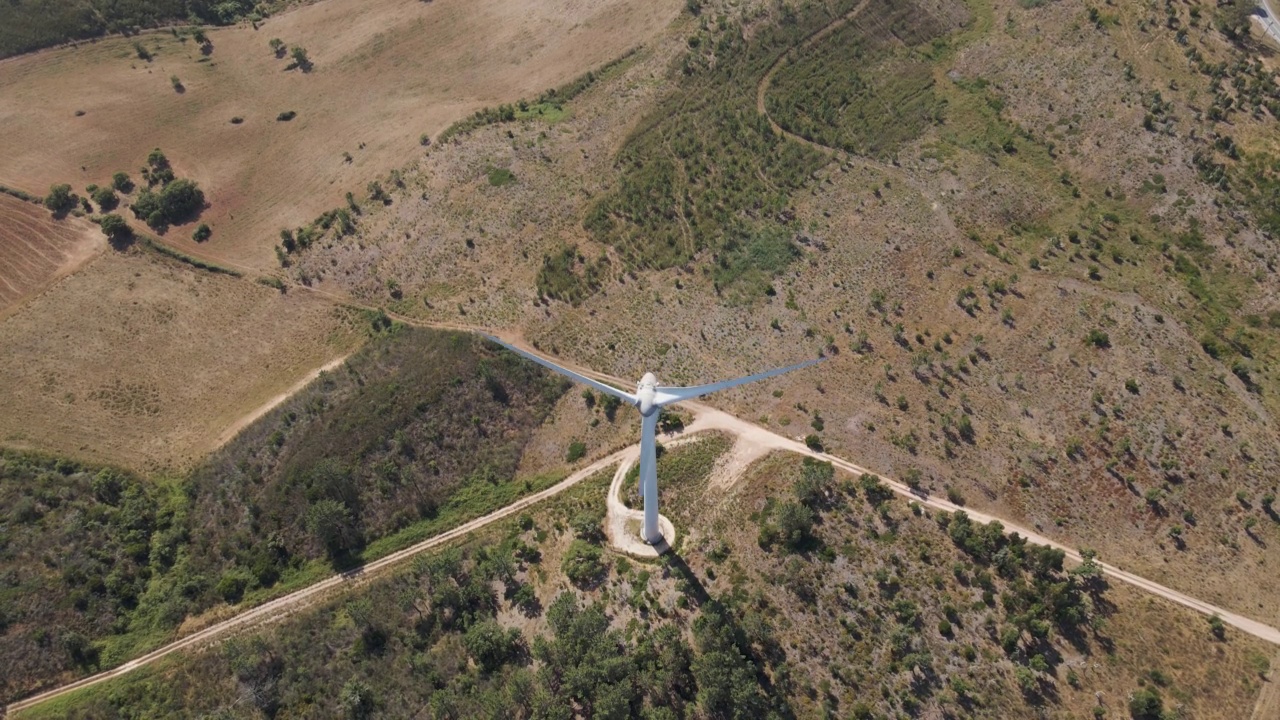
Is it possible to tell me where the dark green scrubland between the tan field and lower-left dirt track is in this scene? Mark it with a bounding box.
[0,324,566,698]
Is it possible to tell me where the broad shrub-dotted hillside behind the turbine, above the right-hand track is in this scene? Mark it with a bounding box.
[285,1,1280,627]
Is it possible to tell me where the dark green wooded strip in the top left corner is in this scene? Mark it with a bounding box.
[0,0,269,58]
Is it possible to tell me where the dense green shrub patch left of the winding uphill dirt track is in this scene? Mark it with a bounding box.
[585,1,855,281]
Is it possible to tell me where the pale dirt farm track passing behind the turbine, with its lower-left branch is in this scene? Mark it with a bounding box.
[15,278,1280,712]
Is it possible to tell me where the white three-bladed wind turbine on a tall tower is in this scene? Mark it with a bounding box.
[484,336,823,544]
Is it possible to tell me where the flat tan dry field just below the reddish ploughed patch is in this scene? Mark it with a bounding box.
[0,250,360,471]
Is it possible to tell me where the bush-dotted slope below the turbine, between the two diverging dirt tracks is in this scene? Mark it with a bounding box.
[27,439,1265,717]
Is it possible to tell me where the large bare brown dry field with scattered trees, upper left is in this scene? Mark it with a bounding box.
[0,0,680,269]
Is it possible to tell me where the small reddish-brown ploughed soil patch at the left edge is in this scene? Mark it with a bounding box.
[0,195,106,318]
